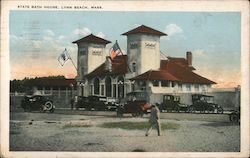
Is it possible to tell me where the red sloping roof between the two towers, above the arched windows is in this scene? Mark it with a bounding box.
[86,55,128,77]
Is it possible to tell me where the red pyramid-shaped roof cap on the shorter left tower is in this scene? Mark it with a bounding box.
[72,34,111,44]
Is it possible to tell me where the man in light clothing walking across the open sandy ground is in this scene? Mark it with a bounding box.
[146,105,161,136]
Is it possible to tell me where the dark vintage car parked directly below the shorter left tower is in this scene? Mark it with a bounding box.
[76,95,107,111]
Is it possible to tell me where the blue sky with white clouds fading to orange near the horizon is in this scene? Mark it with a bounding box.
[9,11,241,88]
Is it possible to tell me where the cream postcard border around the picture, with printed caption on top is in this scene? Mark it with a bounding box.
[0,0,250,158]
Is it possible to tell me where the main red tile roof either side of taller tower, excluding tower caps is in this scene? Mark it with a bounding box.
[86,55,215,84]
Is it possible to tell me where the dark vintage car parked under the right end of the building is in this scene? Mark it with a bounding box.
[189,94,223,114]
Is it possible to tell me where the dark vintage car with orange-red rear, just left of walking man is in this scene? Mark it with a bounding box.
[117,92,151,117]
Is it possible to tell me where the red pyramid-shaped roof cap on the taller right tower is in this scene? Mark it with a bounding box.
[122,25,167,36]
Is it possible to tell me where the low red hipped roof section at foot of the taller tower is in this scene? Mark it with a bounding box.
[131,70,180,81]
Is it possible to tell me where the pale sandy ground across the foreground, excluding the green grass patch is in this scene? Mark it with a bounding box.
[10,112,240,152]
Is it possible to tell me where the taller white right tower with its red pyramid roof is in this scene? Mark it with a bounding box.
[122,25,166,77]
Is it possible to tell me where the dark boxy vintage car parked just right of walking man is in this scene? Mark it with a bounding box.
[156,94,188,112]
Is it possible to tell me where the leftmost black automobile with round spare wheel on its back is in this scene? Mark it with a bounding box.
[21,95,55,113]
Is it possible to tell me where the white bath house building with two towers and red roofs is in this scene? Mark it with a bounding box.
[73,25,215,103]
